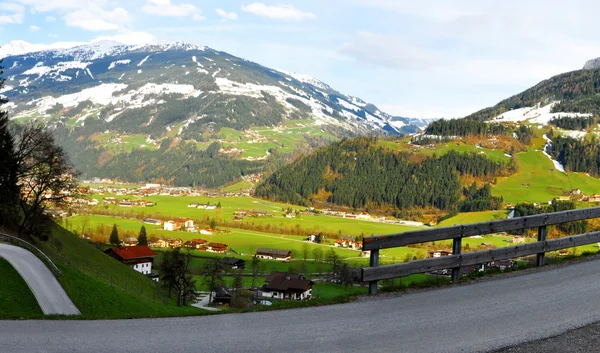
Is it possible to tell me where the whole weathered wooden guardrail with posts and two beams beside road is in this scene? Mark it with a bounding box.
[361,207,600,294]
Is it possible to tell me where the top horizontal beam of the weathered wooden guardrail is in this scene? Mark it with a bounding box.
[363,207,600,250]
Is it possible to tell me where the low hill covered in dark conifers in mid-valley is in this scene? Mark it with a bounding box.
[256,138,515,211]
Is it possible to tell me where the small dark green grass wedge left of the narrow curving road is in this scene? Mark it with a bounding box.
[0,258,43,318]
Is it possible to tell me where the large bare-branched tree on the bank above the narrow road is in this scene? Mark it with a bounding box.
[13,125,77,240]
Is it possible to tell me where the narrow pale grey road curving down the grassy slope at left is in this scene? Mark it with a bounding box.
[0,243,81,314]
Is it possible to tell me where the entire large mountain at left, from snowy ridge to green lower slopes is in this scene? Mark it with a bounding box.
[0,41,436,186]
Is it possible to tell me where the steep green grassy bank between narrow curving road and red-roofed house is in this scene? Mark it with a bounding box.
[38,226,200,318]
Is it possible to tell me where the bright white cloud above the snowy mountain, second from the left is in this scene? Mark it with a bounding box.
[63,7,130,32]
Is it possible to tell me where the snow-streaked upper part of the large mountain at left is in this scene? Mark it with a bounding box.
[0,41,428,134]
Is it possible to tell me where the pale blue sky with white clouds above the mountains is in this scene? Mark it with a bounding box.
[0,0,600,118]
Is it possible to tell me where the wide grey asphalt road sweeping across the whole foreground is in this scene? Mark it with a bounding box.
[0,260,600,353]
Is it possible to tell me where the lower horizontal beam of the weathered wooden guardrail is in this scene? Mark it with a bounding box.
[362,232,600,282]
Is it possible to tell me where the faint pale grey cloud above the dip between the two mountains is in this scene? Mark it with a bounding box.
[339,32,436,70]
